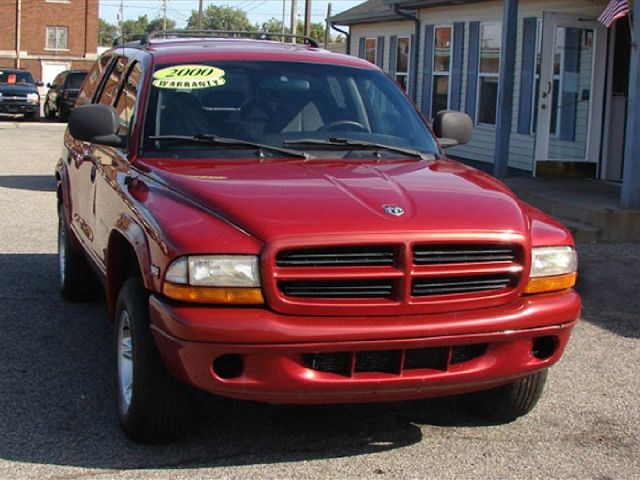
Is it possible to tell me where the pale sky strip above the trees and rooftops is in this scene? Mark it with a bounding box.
[100,0,364,28]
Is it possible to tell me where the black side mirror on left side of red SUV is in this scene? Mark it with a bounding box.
[69,103,126,147]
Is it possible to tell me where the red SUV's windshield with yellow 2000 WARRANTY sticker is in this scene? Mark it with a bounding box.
[143,60,437,158]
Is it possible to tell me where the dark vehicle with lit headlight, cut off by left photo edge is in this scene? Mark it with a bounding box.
[0,68,42,120]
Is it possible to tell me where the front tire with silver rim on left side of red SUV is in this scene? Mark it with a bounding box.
[115,278,193,443]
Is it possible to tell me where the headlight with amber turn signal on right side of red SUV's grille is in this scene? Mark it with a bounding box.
[525,247,578,293]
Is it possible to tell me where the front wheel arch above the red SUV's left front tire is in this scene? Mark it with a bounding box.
[105,221,153,319]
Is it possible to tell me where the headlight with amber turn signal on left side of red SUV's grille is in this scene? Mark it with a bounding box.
[163,255,264,305]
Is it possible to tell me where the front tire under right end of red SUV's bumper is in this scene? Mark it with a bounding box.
[466,370,547,423]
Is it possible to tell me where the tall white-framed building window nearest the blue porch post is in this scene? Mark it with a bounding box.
[476,23,502,125]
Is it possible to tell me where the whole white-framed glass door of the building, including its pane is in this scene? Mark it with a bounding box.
[534,12,607,172]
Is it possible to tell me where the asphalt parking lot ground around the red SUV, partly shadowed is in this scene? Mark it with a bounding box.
[0,120,640,480]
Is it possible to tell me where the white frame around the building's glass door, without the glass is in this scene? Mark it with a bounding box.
[533,12,607,175]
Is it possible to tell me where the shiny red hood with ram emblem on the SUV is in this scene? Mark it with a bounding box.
[144,160,527,242]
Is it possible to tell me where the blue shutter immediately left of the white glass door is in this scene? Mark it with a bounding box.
[518,17,538,135]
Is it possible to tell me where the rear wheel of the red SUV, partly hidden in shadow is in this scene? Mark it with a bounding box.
[58,203,100,302]
